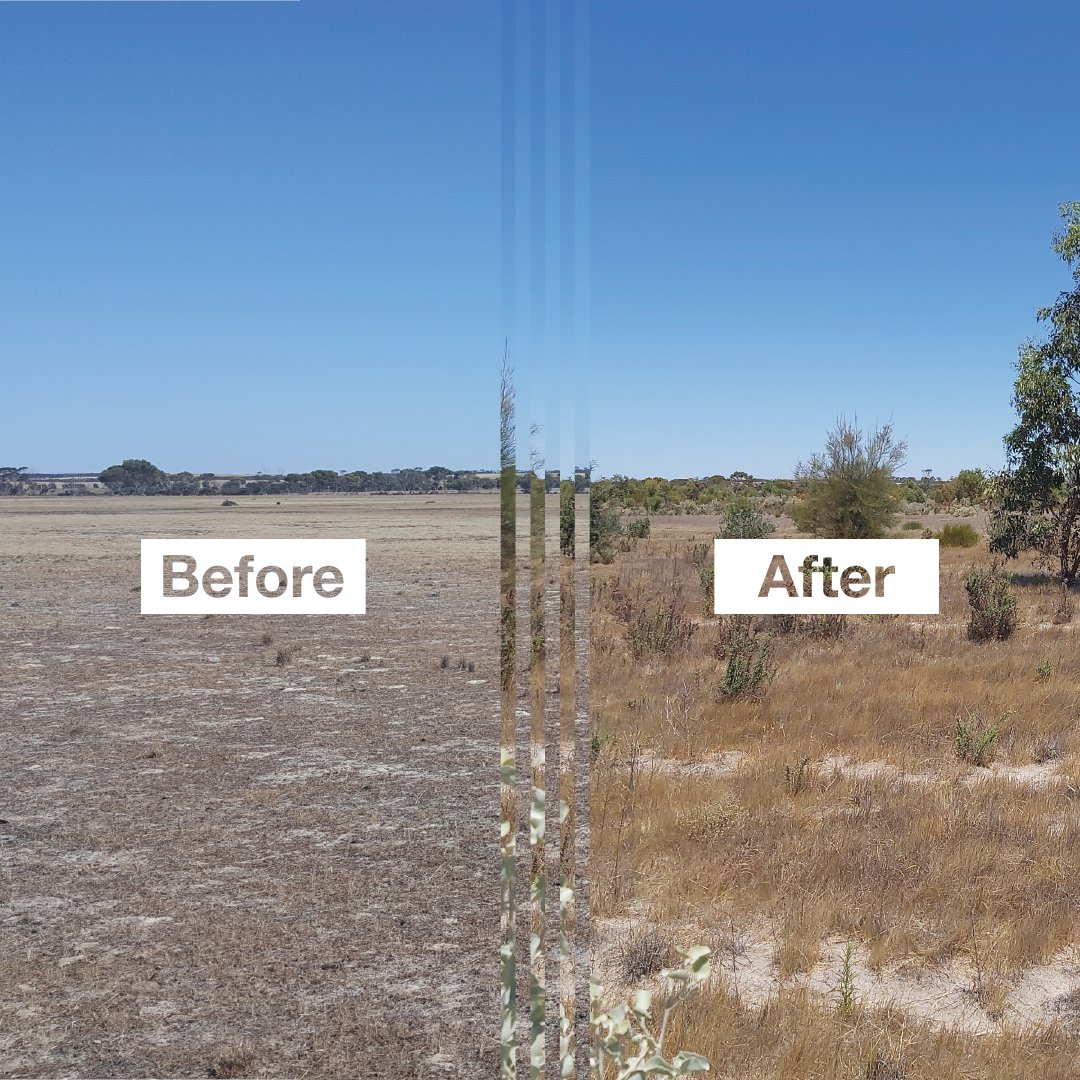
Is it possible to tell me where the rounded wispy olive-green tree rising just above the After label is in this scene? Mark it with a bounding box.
[791,417,907,539]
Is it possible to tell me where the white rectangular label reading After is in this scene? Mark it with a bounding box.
[713,539,941,615]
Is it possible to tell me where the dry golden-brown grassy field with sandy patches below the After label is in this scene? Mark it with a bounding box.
[591,517,1080,1080]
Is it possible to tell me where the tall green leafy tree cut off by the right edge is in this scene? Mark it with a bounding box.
[989,202,1080,589]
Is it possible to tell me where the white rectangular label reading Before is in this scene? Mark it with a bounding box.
[139,538,367,615]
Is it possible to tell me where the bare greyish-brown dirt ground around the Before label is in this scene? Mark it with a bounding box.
[0,496,499,1078]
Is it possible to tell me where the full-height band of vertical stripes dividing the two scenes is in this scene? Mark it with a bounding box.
[499,0,590,1080]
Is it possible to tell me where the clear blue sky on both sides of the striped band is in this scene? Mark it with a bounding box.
[0,0,1080,475]
